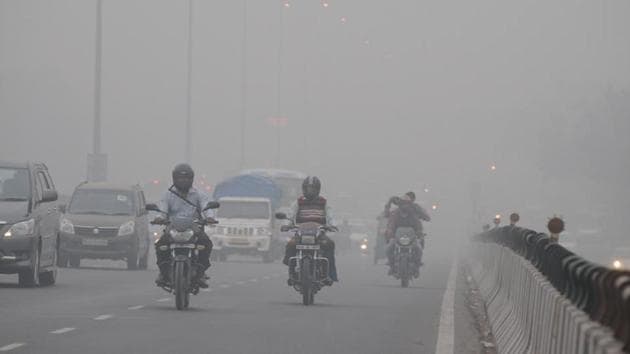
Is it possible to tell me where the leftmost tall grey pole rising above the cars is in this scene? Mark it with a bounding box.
[92,0,103,155]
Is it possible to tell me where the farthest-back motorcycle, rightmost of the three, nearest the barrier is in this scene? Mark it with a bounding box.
[392,227,424,288]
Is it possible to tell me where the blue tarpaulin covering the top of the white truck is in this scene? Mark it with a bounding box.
[212,174,282,210]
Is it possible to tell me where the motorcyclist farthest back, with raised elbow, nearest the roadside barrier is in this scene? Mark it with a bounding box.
[384,192,431,274]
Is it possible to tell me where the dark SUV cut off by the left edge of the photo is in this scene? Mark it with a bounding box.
[0,162,59,286]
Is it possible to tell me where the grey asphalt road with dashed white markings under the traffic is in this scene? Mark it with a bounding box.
[0,235,476,354]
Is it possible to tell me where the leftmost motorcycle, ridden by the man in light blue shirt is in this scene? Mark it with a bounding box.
[146,202,219,311]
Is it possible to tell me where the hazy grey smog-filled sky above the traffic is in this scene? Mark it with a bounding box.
[0,0,630,231]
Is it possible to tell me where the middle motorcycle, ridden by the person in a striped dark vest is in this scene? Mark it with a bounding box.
[276,213,337,306]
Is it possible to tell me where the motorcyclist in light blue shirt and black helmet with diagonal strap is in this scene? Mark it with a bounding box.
[152,163,216,288]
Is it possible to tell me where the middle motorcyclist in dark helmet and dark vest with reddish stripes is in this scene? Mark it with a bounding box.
[282,176,338,285]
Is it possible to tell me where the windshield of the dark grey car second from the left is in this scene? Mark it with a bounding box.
[68,189,135,215]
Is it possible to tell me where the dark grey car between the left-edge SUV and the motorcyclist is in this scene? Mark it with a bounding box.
[59,182,151,269]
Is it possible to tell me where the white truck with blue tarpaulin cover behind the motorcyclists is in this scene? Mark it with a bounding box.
[211,174,282,263]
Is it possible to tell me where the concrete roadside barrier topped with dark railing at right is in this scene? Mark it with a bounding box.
[470,226,630,353]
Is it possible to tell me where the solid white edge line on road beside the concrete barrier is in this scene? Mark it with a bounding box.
[435,255,457,354]
